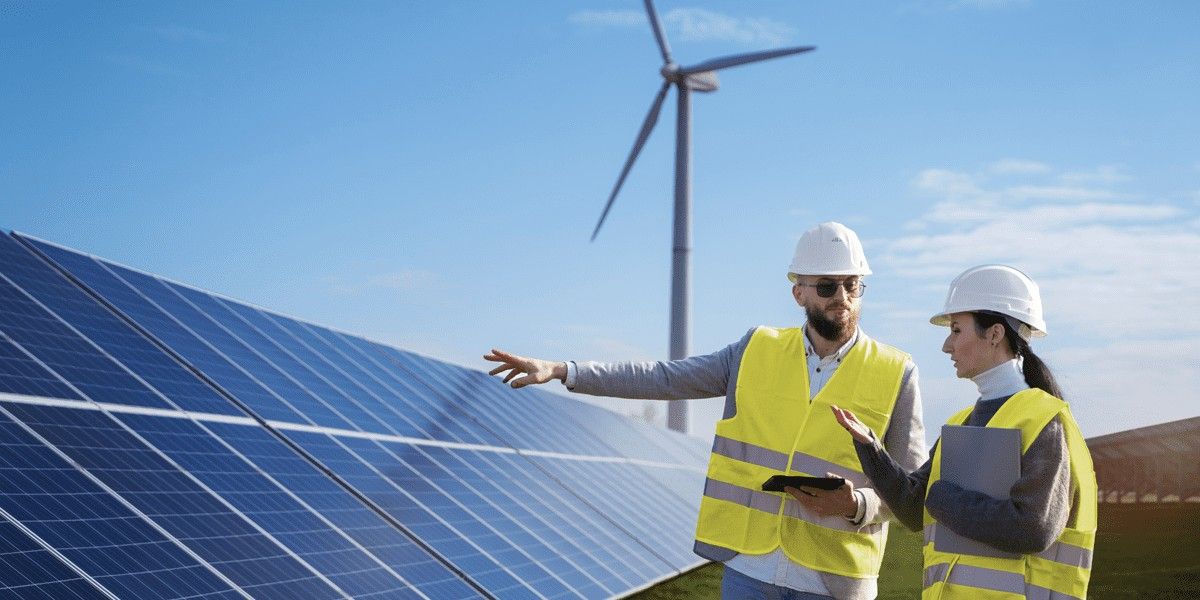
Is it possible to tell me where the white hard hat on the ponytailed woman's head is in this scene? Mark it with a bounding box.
[929,264,1046,340]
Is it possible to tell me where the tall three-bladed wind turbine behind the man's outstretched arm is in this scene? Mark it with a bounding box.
[592,0,816,433]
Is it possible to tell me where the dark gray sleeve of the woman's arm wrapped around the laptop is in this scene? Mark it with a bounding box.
[926,418,1070,554]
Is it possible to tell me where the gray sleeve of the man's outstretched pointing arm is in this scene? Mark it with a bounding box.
[571,329,754,400]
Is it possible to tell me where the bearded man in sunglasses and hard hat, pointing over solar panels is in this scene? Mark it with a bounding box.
[484,222,925,600]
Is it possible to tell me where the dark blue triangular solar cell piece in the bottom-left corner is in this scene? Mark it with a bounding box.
[0,517,107,600]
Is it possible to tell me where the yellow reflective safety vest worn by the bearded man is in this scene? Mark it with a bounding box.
[696,326,908,577]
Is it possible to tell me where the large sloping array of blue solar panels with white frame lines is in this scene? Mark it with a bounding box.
[0,233,708,600]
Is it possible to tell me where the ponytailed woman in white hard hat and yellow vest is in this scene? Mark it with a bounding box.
[833,265,1097,600]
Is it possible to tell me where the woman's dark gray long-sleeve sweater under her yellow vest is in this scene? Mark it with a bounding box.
[854,365,1072,553]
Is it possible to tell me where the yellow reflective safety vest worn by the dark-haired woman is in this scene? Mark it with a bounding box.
[922,389,1098,600]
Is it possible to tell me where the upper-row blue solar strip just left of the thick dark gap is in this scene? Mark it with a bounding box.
[0,235,241,414]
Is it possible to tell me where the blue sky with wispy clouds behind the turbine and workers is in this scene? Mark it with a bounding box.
[0,0,1200,437]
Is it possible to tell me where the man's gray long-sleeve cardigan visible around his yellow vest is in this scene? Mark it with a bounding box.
[570,328,925,599]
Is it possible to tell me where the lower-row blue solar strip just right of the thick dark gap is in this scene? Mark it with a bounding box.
[288,432,535,599]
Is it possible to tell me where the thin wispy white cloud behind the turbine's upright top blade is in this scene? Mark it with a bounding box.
[566,8,796,46]
